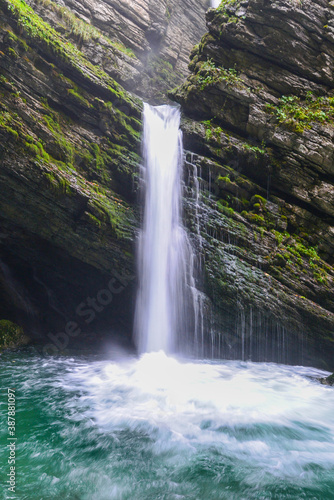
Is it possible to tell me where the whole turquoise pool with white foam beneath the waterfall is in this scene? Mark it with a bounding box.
[0,351,334,500]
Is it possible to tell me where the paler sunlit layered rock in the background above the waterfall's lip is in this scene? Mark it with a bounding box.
[28,0,208,102]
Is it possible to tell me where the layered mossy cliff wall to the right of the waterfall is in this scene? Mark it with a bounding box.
[170,0,334,367]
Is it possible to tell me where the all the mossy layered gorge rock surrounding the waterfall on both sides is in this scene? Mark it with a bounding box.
[0,0,334,369]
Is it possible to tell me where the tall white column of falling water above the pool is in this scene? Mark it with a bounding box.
[135,104,194,353]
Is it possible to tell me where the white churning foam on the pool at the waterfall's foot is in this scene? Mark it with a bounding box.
[64,352,334,481]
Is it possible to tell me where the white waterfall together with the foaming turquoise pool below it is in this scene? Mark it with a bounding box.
[0,104,334,500]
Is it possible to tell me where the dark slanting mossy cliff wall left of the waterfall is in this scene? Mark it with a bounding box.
[0,1,142,341]
